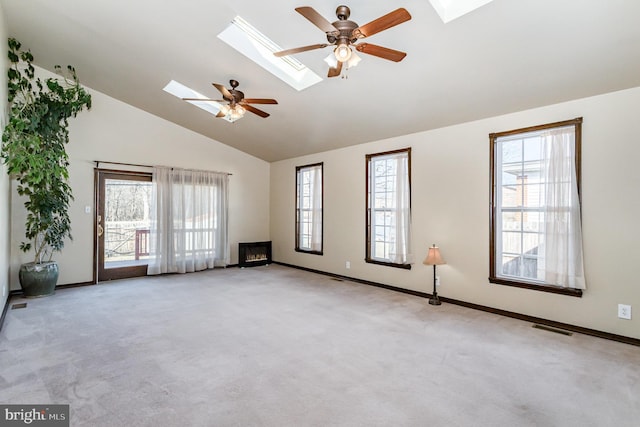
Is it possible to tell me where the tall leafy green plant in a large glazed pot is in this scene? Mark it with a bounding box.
[0,38,91,297]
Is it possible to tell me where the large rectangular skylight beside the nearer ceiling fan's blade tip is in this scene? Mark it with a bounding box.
[218,16,322,90]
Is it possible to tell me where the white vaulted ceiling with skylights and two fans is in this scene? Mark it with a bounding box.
[5,0,640,161]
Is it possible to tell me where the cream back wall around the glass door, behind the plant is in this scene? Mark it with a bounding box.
[11,69,270,289]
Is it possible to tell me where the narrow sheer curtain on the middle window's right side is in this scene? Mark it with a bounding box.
[389,152,413,264]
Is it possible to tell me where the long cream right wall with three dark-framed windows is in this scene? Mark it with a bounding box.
[271,88,640,338]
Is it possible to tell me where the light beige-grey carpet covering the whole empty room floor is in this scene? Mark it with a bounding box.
[0,265,640,427]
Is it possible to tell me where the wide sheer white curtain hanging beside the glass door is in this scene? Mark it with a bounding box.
[147,167,229,274]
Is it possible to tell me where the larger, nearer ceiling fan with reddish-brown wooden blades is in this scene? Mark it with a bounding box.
[274,5,411,77]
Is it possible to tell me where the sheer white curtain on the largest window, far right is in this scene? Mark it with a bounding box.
[542,126,585,289]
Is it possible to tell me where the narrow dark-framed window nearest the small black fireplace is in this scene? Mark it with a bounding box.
[296,163,323,255]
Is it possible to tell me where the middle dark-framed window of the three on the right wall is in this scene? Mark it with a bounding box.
[365,148,412,269]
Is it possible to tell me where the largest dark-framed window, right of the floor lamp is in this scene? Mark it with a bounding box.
[489,118,585,296]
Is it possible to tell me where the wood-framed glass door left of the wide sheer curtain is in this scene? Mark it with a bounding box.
[95,169,151,282]
